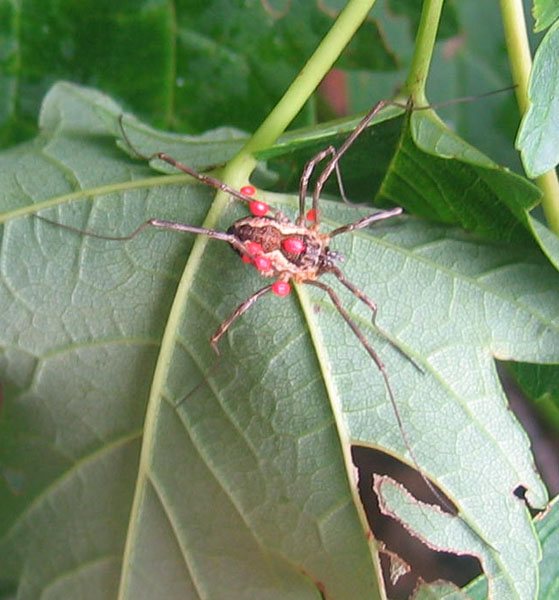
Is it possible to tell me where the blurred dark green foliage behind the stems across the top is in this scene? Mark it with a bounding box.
[0,0,540,169]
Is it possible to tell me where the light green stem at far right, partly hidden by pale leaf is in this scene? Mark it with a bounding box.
[501,0,559,234]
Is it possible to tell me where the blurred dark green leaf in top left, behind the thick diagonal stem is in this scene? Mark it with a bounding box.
[0,0,396,143]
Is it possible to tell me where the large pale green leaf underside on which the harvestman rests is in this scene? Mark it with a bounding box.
[0,84,559,600]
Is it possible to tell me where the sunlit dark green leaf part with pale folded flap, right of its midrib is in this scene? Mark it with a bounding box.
[388,111,540,241]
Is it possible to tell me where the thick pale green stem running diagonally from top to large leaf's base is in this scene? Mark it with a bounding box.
[223,0,376,185]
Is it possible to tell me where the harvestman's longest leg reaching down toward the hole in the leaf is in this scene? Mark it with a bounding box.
[304,280,456,513]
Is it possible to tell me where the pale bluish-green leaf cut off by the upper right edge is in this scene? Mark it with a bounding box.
[516,21,559,178]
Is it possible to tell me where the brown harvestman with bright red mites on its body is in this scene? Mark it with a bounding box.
[38,101,456,508]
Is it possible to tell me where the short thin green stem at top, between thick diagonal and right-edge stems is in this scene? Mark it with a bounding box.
[404,0,444,106]
